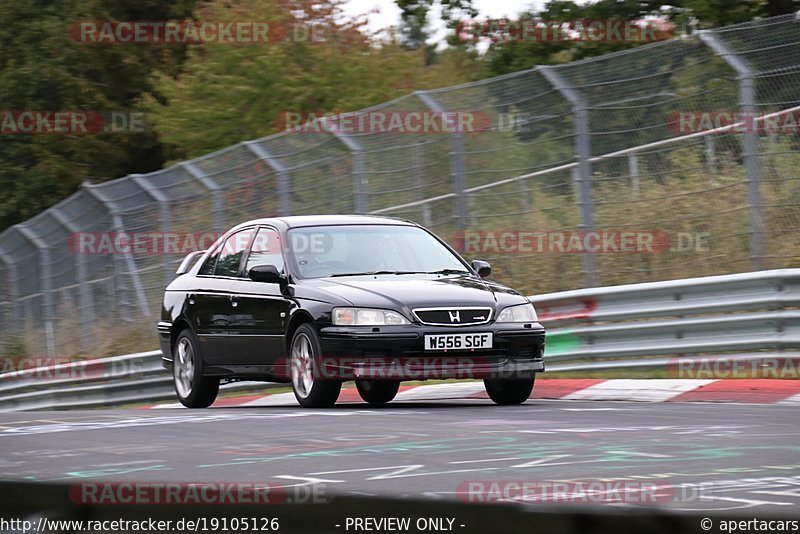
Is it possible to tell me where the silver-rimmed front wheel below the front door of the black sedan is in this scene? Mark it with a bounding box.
[289,324,342,408]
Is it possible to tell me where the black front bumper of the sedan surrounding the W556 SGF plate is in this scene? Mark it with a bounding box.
[317,323,544,380]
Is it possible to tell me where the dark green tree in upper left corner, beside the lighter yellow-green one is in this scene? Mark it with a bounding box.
[0,0,194,229]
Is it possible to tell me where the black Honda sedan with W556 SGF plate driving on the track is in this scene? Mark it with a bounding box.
[158,215,544,408]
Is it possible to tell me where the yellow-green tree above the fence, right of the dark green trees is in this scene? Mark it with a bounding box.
[143,0,479,158]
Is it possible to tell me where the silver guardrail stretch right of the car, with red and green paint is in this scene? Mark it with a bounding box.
[530,269,800,370]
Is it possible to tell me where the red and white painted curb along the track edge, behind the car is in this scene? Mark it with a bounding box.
[146,378,800,409]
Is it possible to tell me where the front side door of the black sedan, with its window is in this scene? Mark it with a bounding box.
[229,227,293,373]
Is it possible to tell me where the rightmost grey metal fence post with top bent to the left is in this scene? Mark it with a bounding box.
[698,30,764,271]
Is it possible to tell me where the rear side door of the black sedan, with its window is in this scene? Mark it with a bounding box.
[186,228,254,365]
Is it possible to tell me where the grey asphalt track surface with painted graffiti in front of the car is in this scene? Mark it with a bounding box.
[0,399,800,516]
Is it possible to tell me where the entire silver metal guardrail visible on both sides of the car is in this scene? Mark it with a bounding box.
[0,269,800,410]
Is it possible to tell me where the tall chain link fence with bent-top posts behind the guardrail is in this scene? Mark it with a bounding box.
[0,16,800,356]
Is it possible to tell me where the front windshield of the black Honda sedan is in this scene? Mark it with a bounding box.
[289,225,469,278]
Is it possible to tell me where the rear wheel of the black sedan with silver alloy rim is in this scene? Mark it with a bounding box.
[172,329,219,408]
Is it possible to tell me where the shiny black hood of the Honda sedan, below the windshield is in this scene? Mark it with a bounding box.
[306,275,526,312]
